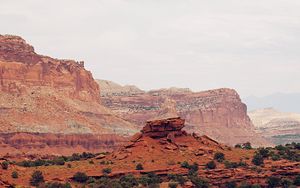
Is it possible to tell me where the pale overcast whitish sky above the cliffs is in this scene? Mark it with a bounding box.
[0,0,300,96]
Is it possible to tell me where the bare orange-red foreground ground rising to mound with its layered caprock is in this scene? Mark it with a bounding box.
[0,118,300,187]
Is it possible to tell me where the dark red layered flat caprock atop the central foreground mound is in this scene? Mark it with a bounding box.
[141,117,185,138]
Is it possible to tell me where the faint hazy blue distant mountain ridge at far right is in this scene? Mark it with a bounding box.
[243,93,300,113]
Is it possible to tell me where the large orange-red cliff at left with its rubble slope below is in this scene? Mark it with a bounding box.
[0,35,136,150]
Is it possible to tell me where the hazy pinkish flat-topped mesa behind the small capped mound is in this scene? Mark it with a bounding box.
[100,81,269,146]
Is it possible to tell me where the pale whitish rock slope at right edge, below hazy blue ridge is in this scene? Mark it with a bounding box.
[248,108,300,144]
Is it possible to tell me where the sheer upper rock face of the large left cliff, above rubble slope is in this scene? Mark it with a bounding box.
[0,35,100,102]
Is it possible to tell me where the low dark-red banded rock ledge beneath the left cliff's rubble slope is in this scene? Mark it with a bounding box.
[0,133,128,157]
